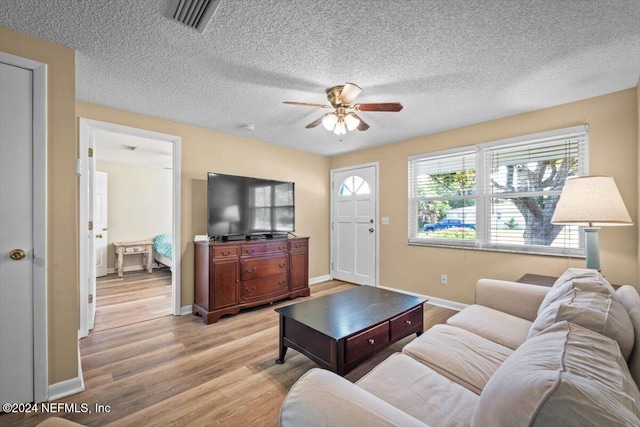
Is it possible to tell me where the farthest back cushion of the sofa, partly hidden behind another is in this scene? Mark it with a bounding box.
[538,268,618,315]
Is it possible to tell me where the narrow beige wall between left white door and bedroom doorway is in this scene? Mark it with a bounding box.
[0,27,78,384]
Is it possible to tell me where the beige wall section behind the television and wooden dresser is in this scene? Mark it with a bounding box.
[76,102,329,306]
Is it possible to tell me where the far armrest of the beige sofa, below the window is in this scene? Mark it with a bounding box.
[476,279,551,322]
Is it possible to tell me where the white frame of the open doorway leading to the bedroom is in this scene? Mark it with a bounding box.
[78,117,182,338]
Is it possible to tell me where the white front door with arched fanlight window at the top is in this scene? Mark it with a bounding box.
[331,164,378,286]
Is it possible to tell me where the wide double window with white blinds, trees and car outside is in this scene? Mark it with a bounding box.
[409,125,588,255]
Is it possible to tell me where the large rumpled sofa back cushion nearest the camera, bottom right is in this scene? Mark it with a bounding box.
[471,322,640,427]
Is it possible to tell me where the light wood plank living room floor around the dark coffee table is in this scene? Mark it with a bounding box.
[0,279,455,426]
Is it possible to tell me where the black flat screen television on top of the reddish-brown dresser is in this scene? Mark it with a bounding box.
[207,172,295,239]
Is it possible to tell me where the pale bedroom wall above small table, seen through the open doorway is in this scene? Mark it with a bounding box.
[96,161,173,269]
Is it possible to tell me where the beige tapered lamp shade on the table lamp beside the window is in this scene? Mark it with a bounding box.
[551,175,633,227]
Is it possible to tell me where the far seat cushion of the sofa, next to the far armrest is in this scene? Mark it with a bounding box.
[447,304,532,350]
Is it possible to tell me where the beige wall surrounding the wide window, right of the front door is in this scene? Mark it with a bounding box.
[331,88,639,303]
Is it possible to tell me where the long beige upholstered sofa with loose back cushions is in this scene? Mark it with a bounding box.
[280,269,640,427]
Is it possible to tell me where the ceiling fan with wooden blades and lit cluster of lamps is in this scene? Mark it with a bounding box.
[284,83,402,135]
